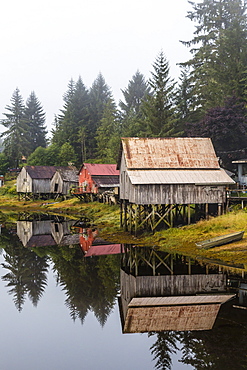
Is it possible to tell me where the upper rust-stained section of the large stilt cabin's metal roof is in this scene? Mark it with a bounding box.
[122,137,219,169]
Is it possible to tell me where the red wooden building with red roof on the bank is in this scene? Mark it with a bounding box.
[78,163,119,194]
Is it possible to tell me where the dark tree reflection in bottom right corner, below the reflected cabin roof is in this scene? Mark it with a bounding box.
[149,303,247,370]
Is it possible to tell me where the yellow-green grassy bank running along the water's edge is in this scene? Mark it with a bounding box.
[0,195,247,265]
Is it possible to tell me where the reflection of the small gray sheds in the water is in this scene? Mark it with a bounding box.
[17,220,79,248]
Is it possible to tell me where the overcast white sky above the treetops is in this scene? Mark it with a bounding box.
[0,0,195,131]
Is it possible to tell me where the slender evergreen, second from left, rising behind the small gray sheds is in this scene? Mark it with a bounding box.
[24,92,47,153]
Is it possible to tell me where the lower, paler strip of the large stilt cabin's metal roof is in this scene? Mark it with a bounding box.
[127,168,235,185]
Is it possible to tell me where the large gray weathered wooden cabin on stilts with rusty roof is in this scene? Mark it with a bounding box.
[118,137,234,231]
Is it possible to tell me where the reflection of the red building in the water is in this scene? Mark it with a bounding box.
[79,227,122,257]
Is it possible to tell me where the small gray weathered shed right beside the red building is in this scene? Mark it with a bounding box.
[51,167,79,197]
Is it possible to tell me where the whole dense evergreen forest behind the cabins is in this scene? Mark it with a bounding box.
[0,0,247,173]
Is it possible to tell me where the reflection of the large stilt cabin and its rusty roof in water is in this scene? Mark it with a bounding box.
[119,247,234,333]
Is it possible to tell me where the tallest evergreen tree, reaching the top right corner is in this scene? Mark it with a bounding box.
[180,0,247,118]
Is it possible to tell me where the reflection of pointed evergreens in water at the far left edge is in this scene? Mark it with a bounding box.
[0,236,48,311]
